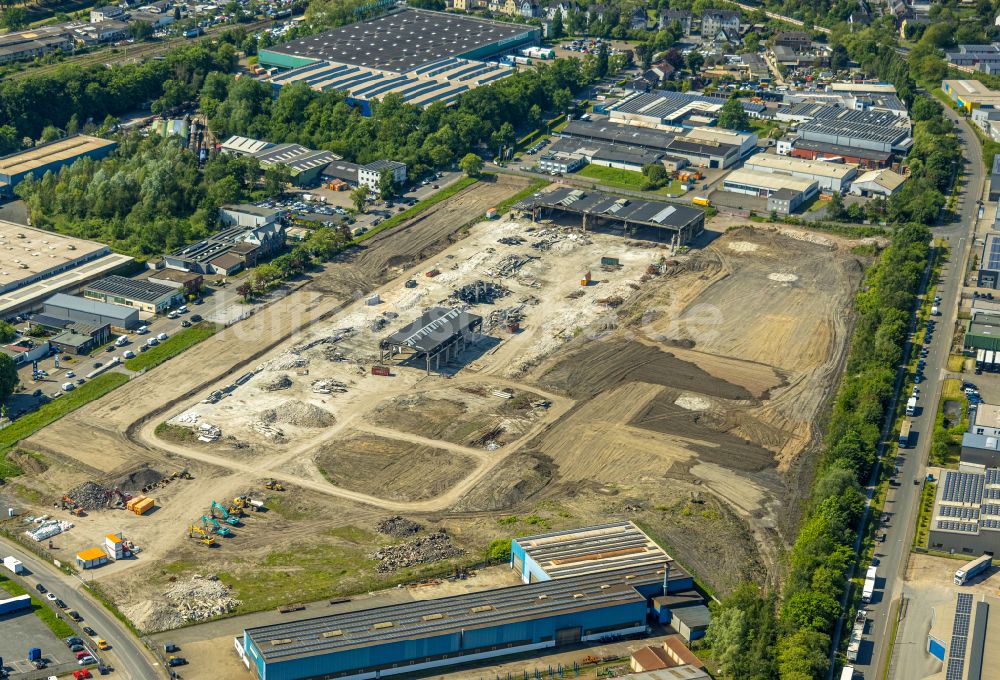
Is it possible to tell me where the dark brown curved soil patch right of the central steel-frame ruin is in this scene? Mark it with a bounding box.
[542,339,753,400]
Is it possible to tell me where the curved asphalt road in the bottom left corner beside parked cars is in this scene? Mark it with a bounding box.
[0,538,166,680]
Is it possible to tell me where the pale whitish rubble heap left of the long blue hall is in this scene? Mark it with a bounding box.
[122,574,240,633]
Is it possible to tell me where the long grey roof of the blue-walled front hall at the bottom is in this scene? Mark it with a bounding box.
[245,567,663,663]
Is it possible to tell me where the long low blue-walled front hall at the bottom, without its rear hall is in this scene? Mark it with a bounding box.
[236,568,663,680]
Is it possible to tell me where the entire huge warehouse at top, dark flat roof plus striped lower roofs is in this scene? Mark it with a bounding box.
[260,8,541,115]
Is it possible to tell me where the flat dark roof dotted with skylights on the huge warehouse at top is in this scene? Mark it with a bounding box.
[268,8,538,72]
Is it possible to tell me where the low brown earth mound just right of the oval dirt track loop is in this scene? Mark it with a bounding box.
[451,453,555,512]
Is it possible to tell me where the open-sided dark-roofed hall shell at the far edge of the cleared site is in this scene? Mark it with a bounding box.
[514,187,705,245]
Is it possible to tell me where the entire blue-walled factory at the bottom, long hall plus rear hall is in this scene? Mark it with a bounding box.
[236,522,704,680]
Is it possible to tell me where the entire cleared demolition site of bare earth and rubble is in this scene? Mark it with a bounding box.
[2,177,866,677]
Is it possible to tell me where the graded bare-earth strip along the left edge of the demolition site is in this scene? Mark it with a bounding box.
[25,176,527,477]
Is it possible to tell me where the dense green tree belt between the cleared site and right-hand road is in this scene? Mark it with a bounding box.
[707,224,931,680]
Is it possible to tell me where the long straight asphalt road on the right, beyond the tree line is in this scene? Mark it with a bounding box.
[843,103,986,680]
